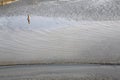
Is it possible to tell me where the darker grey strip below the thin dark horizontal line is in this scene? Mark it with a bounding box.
[0,65,120,80]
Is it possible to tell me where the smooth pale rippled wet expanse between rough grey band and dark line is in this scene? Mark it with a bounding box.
[0,15,120,65]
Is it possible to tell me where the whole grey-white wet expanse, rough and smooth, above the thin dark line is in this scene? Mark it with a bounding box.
[0,0,120,65]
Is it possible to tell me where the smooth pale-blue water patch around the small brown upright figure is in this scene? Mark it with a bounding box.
[0,15,79,30]
